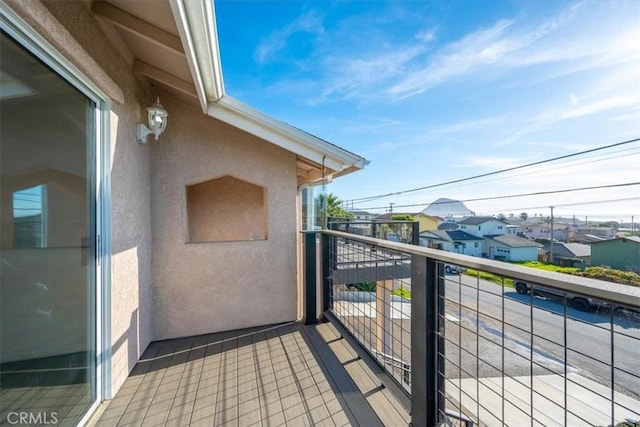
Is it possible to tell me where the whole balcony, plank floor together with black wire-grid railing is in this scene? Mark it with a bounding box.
[99,231,640,426]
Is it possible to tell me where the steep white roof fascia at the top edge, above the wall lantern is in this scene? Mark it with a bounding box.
[169,0,224,114]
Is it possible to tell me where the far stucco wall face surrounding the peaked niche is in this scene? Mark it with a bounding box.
[148,95,296,339]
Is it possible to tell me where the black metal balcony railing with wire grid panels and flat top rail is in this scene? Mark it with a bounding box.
[305,230,640,426]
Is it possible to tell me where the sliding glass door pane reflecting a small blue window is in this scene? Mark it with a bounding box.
[0,32,97,425]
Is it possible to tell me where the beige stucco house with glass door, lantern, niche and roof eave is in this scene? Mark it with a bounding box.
[0,0,367,425]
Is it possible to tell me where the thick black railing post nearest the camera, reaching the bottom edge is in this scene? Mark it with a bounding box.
[411,255,444,427]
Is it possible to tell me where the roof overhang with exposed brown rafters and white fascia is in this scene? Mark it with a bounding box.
[92,0,369,185]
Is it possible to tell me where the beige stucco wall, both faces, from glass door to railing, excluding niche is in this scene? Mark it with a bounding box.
[6,0,297,402]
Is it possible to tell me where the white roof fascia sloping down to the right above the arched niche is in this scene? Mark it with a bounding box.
[208,95,369,176]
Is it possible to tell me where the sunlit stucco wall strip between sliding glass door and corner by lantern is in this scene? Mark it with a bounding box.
[7,0,153,390]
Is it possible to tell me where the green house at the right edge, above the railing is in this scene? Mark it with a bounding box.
[591,237,640,272]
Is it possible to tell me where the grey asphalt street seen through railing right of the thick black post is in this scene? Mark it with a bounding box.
[445,275,640,397]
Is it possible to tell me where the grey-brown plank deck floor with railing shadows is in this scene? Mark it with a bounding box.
[92,323,409,427]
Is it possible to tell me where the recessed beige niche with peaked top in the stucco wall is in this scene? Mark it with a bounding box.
[187,176,267,243]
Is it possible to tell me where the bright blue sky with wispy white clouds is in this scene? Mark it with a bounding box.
[215,0,640,221]
